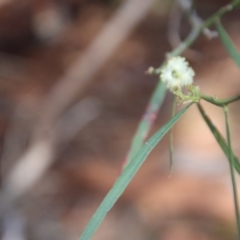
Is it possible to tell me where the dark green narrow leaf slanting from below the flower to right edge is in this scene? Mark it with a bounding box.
[198,104,240,174]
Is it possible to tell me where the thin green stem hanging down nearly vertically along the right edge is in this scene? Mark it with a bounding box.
[223,105,240,239]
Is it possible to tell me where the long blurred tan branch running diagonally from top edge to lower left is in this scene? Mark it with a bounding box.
[1,0,153,214]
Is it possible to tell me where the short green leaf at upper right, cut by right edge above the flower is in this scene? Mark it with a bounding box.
[216,20,240,68]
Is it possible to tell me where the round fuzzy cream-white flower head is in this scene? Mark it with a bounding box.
[160,56,195,91]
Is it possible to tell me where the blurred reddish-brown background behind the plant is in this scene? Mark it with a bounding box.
[0,0,240,240]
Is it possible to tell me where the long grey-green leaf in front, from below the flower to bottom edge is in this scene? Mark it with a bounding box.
[80,103,192,240]
